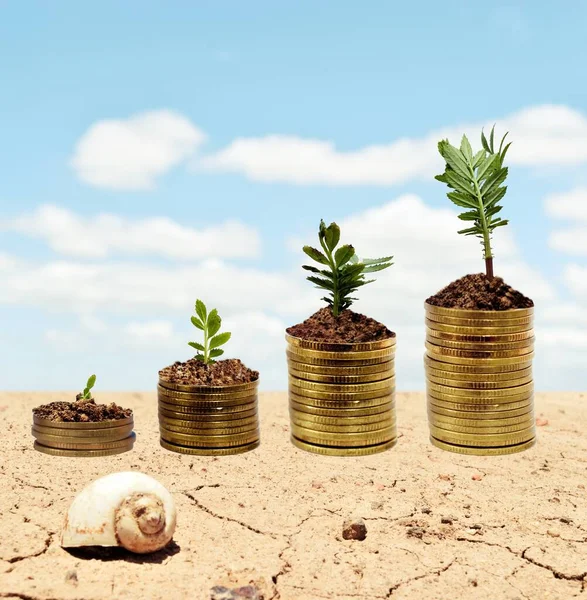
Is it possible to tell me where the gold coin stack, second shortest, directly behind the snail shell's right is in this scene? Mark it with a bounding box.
[157,379,260,456]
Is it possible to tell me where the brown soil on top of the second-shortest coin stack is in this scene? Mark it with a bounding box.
[159,358,259,386]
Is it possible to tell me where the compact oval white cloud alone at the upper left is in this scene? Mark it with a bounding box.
[70,110,205,190]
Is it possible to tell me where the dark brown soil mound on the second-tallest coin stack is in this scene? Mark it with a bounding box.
[286,306,395,344]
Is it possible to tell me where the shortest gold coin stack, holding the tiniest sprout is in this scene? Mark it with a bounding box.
[32,415,135,457]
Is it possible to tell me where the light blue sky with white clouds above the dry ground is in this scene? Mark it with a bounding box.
[0,1,587,389]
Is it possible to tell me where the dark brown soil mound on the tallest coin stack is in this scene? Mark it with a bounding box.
[426,273,534,310]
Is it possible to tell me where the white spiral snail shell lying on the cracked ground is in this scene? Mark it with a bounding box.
[61,471,177,554]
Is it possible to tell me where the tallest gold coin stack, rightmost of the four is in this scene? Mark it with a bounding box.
[424,303,536,455]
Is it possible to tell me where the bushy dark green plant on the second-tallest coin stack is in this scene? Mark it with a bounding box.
[302,220,393,317]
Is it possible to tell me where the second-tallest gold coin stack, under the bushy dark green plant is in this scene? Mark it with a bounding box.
[286,335,397,456]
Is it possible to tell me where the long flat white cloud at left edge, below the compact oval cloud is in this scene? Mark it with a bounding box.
[0,205,261,258]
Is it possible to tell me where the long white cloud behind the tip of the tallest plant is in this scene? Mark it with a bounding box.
[200,105,587,186]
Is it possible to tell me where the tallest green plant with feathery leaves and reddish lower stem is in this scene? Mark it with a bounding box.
[436,126,511,278]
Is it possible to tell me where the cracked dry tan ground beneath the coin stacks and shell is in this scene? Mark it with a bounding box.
[0,393,587,600]
